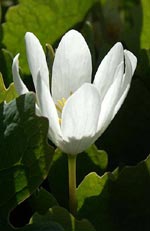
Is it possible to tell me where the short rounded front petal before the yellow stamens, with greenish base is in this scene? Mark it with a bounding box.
[61,83,100,154]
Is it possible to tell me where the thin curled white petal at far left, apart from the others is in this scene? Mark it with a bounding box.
[12,54,29,95]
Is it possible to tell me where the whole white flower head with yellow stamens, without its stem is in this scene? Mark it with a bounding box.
[12,30,137,154]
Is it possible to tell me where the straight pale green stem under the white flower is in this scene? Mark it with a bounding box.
[68,155,77,216]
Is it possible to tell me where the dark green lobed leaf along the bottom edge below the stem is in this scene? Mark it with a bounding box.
[31,206,95,231]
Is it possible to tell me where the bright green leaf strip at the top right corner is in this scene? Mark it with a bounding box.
[140,0,150,49]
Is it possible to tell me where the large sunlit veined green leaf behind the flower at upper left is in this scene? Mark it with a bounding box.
[3,0,95,73]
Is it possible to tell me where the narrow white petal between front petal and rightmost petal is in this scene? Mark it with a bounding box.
[97,62,124,136]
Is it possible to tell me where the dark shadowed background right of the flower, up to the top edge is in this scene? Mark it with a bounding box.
[90,0,150,170]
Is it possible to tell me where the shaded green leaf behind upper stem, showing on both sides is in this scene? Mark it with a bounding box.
[48,145,108,207]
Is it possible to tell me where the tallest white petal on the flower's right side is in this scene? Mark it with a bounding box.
[94,42,124,99]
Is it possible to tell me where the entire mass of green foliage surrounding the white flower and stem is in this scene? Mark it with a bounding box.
[0,0,150,231]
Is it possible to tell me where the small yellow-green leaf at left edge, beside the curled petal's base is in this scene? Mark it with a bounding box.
[0,73,17,103]
